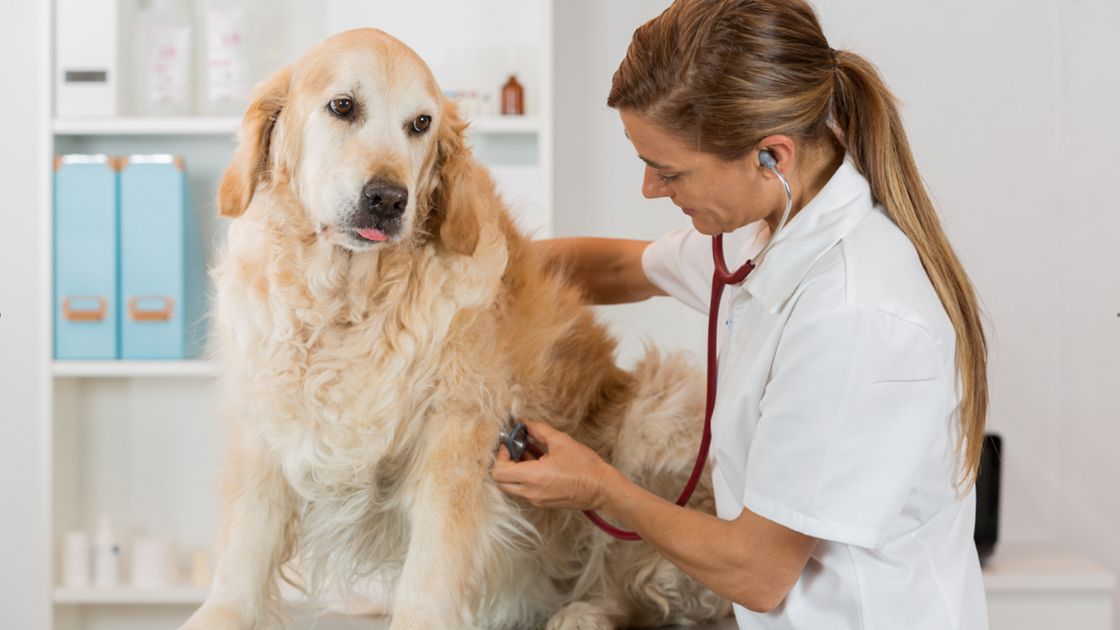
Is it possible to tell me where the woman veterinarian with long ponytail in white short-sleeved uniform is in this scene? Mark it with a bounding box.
[493,0,987,630]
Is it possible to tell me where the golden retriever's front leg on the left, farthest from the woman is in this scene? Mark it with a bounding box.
[180,423,292,630]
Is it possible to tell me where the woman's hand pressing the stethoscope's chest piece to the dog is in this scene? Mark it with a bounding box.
[491,420,614,510]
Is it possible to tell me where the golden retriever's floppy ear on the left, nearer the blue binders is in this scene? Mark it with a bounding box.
[217,66,291,217]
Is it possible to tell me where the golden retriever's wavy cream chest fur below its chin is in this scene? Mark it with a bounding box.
[213,208,508,583]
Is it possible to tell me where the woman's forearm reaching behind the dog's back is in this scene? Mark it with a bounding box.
[533,237,664,304]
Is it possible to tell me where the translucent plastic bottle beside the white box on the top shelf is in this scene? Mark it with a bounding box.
[133,0,193,115]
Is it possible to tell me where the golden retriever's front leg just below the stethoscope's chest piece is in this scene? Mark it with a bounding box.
[390,414,508,630]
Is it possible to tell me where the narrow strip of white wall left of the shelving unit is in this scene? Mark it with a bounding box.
[0,2,50,629]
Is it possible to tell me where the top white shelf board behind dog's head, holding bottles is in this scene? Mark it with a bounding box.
[52,115,541,137]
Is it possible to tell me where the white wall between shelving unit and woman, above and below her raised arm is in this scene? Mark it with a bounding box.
[553,0,707,365]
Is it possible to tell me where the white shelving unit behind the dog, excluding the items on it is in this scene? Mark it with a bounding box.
[37,0,553,630]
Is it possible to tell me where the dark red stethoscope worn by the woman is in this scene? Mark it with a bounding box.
[498,149,793,540]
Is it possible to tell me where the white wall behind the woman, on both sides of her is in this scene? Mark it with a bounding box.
[556,0,1120,628]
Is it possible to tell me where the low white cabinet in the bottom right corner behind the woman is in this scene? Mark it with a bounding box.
[983,546,1116,630]
